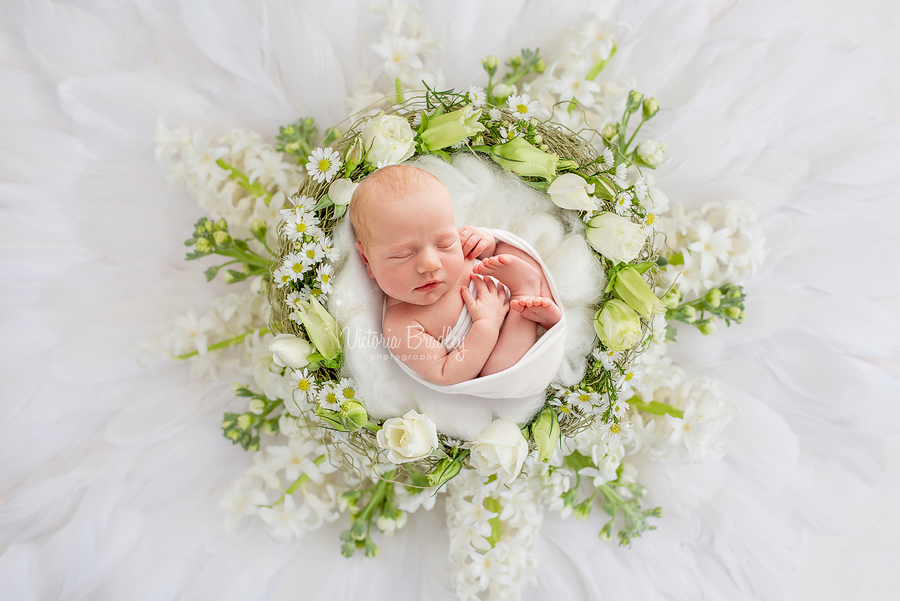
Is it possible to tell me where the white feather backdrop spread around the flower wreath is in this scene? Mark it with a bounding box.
[0,0,900,601]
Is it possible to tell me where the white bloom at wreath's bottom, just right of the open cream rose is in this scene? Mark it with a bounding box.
[469,419,528,484]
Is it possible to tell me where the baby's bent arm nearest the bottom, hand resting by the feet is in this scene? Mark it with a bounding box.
[383,276,509,386]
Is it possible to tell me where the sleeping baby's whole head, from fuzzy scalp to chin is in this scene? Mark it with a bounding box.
[350,165,465,305]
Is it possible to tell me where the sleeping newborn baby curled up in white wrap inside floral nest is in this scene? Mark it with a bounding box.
[350,165,562,385]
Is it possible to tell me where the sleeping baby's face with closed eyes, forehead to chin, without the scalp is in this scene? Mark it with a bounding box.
[356,177,465,305]
